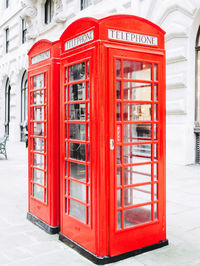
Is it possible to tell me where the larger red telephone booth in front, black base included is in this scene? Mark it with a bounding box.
[60,15,168,264]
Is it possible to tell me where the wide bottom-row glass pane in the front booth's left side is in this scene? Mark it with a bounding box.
[69,200,86,223]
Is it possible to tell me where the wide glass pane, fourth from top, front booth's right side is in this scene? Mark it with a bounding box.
[124,124,151,142]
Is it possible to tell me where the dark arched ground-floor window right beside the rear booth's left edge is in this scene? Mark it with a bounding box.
[20,71,28,141]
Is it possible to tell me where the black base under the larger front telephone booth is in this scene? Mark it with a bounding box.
[59,233,168,265]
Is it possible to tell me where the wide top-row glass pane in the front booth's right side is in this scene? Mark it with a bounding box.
[123,60,151,80]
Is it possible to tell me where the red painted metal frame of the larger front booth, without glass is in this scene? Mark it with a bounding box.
[60,15,166,257]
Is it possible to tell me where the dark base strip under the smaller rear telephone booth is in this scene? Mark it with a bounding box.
[27,212,60,235]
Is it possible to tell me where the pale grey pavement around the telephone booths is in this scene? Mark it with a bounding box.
[0,141,200,266]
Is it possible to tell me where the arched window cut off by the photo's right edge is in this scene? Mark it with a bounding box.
[194,28,200,164]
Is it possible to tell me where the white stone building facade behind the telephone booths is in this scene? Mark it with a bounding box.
[0,0,200,164]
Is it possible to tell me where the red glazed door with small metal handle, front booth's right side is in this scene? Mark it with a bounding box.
[108,49,166,256]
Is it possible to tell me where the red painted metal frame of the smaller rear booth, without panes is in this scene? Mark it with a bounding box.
[28,40,60,227]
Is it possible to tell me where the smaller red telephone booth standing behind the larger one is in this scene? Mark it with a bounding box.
[27,40,60,234]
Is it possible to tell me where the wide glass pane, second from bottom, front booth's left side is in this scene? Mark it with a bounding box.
[70,180,86,202]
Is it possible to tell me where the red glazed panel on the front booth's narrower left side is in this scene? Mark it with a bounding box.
[61,47,95,253]
